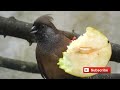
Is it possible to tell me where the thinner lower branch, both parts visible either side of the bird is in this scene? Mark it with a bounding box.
[0,56,120,79]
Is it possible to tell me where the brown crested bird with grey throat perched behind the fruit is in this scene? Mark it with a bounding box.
[30,14,79,79]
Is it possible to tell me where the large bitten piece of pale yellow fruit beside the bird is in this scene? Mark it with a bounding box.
[58,27,112,77]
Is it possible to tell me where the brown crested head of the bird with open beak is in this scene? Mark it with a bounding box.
[30,15,57,41]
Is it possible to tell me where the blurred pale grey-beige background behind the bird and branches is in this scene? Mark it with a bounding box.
[0,11,120,79]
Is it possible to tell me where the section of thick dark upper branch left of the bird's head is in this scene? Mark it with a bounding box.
[0,16,36,45]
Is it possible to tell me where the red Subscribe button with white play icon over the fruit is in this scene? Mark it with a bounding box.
[83,67,111,73]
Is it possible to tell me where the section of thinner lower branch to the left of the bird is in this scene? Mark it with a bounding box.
[0,56,39,73]
